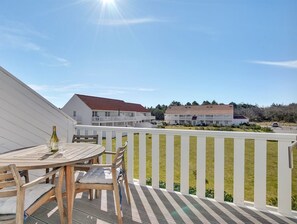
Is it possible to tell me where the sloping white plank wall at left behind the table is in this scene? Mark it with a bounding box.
[0,67,75,153]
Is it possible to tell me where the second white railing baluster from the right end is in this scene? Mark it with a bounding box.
[254,139,267,209]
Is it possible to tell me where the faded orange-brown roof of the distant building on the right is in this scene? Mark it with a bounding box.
[165,104,233,115]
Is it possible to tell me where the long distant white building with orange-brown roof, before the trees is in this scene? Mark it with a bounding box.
[165,104,249,125]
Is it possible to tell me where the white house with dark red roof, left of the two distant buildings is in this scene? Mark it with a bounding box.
[62,94,155,127]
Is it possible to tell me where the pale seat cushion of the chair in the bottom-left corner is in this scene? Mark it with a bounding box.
[0,184,55,214]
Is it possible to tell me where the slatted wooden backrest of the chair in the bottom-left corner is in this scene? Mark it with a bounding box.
[0,164,22,198]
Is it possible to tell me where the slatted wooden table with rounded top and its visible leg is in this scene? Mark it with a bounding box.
[0,143,105,224]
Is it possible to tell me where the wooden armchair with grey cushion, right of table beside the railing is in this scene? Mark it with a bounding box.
[75,142,130,223]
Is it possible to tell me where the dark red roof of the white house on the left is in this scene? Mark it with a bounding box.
[76,94,149,112]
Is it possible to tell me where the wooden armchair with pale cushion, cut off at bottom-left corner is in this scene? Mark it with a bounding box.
[0,164,64,224]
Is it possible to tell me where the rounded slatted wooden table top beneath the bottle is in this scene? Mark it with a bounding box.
[0,143,105,169]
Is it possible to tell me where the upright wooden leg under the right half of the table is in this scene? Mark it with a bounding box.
[65,165,75,224]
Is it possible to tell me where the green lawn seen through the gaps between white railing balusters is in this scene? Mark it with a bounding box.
[104,129,297,206]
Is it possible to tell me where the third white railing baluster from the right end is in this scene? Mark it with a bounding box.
[233,138,245,206]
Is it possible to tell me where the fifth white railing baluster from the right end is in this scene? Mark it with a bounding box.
[196,136,206,198]
